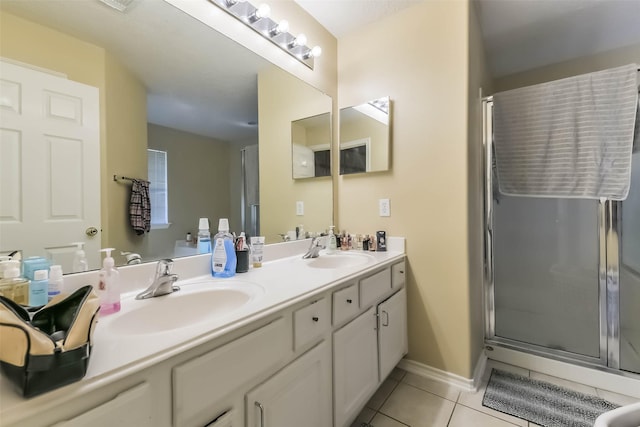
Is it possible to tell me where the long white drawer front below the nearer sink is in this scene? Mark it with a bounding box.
[173,318,291,427]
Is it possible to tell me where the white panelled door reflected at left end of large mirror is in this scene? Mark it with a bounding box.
[0,61,100,273]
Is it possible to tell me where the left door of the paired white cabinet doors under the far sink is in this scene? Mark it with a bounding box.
[333,307,378,427]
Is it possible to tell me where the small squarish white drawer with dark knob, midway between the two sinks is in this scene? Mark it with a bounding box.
[293,298,331,351]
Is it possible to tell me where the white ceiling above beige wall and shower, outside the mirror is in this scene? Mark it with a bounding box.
[295,0,640,77]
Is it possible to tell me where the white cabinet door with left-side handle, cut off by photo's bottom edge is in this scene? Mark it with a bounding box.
[247,341,331,427]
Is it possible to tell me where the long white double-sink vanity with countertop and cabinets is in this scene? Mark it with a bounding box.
[0,238,407,427]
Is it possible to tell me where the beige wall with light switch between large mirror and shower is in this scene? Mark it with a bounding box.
[338,1,482,378]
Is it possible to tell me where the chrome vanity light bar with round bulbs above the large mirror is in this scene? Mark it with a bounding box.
[209,0,322,70]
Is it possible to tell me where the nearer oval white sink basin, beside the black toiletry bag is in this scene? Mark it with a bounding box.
[109,281,264,335]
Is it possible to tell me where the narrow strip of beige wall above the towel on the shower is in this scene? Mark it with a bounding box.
[495,44,640,92]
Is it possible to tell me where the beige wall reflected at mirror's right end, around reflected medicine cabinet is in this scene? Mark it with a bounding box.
[258,67,333,243]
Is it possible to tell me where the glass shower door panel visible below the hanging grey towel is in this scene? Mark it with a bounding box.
[492,196,605,359]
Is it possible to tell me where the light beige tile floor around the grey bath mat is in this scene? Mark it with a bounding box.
[351,360,637,427]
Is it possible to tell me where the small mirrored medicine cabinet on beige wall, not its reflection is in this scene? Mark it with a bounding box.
[340,96,391,175]
